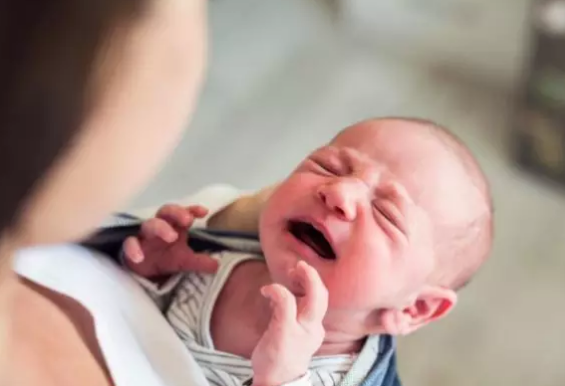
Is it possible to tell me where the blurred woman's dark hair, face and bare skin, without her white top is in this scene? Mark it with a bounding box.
[0,0,206,386]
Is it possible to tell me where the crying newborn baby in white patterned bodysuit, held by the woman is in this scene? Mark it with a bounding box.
[124,118,492,386]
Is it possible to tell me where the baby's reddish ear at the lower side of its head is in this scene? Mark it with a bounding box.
[381,286,457,335]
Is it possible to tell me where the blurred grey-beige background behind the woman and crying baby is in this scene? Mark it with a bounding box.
[130,0,565,386]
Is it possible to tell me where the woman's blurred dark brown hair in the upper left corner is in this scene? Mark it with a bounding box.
[0,0,148,234]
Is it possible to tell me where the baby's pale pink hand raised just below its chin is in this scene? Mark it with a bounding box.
[251,261,328,386]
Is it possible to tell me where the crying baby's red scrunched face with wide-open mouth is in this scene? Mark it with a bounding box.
[260,121,472,311]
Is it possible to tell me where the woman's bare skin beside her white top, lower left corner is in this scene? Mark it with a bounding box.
[8,279,112,386]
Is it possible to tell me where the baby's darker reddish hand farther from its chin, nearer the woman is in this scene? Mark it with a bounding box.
[123,205,218,278]
